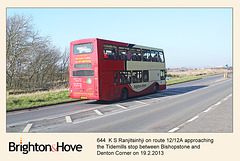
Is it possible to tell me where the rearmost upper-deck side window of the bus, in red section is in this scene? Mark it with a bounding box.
[103,44,118,60]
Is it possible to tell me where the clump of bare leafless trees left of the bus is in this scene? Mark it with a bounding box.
[6,15,69,92]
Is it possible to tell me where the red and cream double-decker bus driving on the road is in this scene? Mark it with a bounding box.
[69,38,166,101]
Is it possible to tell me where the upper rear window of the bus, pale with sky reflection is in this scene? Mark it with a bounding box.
[73,43,93,55]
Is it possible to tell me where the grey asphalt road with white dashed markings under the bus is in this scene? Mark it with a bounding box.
[6,75,233,133]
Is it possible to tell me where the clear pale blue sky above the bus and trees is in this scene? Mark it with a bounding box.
[7,8,232,68]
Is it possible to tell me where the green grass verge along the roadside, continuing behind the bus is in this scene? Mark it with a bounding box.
[6,75,221,111]
